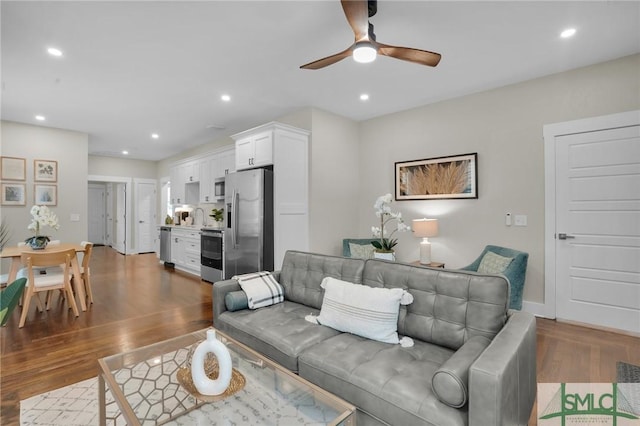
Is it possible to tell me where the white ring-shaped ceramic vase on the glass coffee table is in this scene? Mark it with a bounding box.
[191,330,232,395]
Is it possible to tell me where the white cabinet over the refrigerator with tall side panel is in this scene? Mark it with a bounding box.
[232,122,309,270]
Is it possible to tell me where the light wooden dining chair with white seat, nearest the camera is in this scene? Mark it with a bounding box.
[18,249,79,328]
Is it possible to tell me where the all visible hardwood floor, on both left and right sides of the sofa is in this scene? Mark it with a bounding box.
[0,247,640,425]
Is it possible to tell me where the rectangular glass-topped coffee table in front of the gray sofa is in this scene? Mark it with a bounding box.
[98,329,356,426]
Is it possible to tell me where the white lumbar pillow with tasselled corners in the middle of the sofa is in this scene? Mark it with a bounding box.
[317,277,413,344]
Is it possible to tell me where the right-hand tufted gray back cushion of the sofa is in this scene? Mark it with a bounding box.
[362,260,509,350]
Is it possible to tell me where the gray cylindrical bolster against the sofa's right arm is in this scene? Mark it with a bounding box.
[431,336,491,408]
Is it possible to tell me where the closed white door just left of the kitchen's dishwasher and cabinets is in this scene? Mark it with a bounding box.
[135,182,158,253]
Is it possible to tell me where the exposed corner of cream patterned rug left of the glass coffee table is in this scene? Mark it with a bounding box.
[20,377,111,426]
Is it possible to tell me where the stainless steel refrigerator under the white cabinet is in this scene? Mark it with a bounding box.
[223,169,273,279]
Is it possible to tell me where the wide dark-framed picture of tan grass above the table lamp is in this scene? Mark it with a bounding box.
[395,153,478,201]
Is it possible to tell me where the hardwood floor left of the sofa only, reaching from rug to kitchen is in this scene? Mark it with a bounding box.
[0,247,213,425]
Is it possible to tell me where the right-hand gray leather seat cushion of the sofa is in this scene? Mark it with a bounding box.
[298,333,468,425]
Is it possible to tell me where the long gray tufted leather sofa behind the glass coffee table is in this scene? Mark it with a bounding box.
[213,251,536,426]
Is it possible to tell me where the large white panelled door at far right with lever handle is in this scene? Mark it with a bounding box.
[555,119,640,333]
